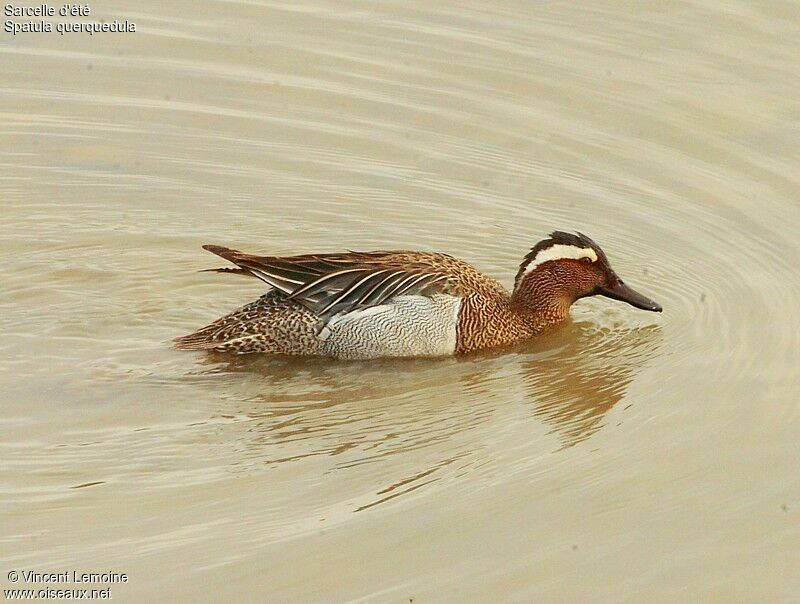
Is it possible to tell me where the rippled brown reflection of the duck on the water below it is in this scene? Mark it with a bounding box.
[195,322,661,510]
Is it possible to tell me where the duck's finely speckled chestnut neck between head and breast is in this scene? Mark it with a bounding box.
[511,271,573,333]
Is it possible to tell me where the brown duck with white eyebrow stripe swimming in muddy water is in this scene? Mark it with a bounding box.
[175,231,662,360]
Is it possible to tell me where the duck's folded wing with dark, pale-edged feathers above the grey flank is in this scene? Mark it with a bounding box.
[203,245,468,318]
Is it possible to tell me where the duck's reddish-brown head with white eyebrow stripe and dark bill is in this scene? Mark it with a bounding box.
[514,231,662,312]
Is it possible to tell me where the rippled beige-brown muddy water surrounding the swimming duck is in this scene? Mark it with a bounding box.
[0,0,800,602]
